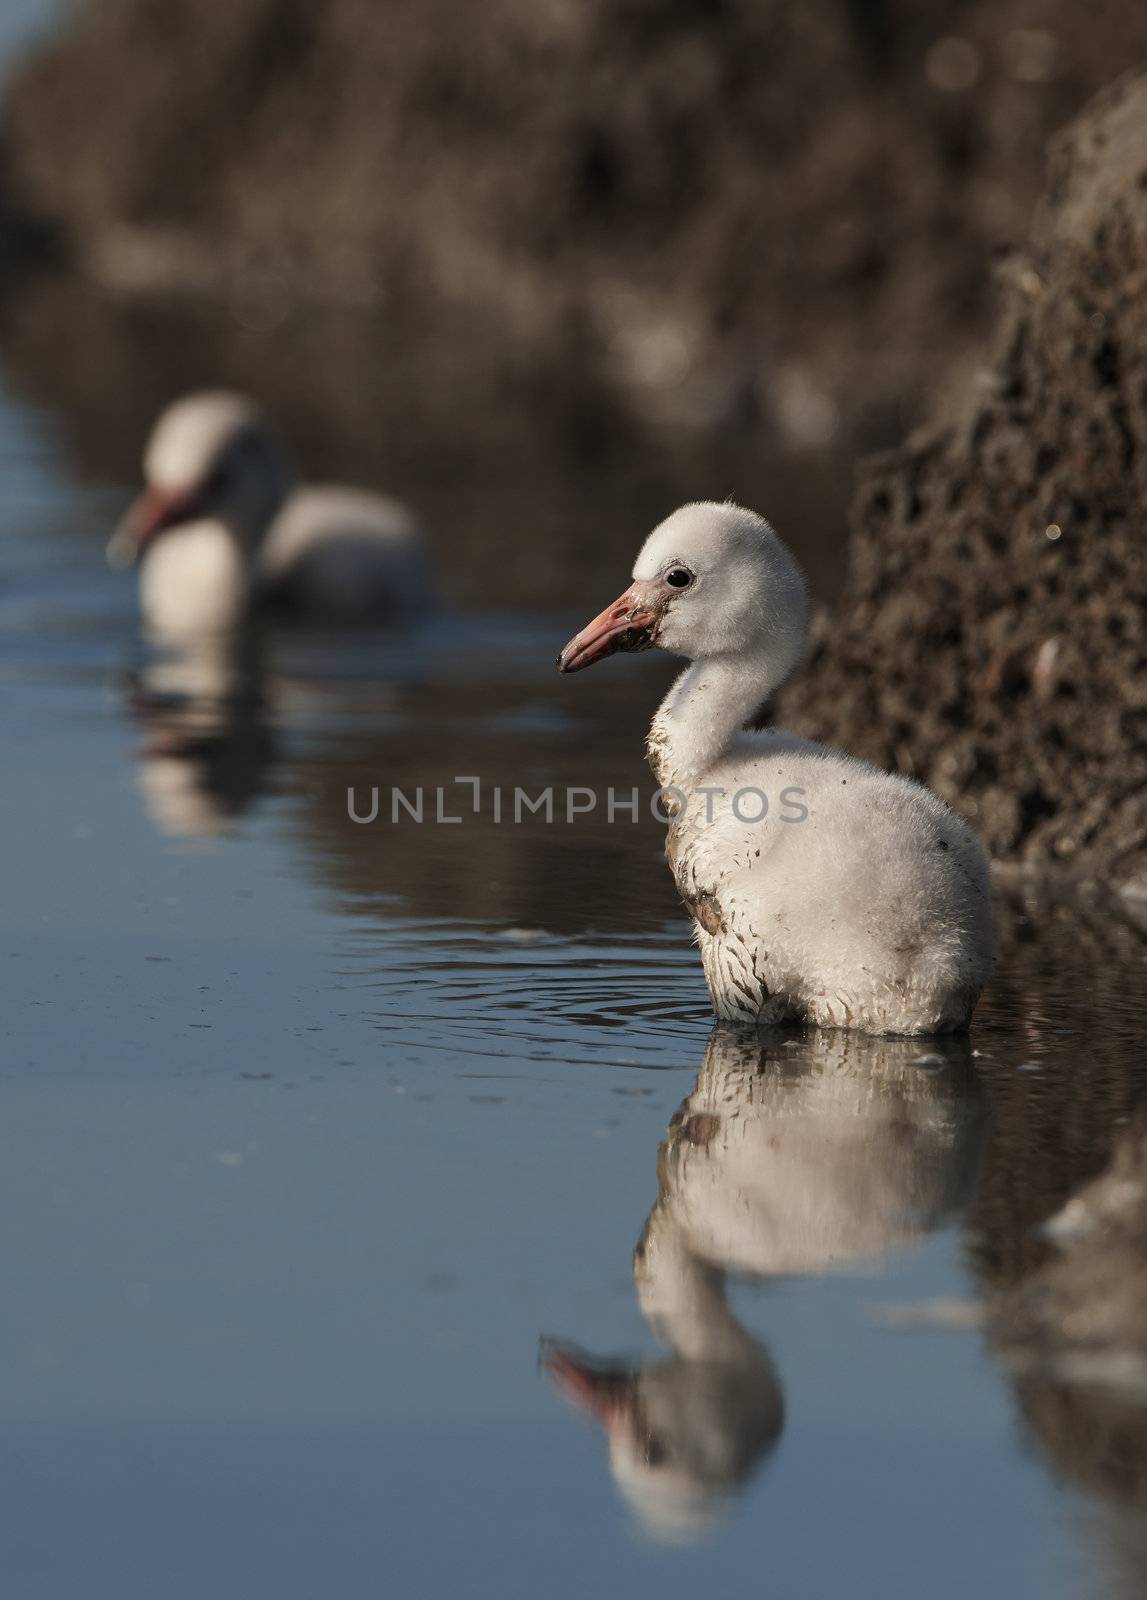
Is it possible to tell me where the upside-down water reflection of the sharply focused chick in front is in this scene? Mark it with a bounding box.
[542,1027,981,1538]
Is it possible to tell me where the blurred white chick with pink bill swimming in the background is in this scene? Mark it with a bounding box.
[109,394,430,638]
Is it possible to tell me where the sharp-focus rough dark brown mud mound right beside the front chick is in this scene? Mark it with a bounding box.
[782,77,1147,891]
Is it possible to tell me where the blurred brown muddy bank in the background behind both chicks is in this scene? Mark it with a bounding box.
[3,0,1147,445]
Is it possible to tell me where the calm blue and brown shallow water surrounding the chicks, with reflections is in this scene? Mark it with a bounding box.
[0,181,1147,1600]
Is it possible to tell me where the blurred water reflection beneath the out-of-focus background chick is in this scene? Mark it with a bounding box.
[130,637,275,838]
